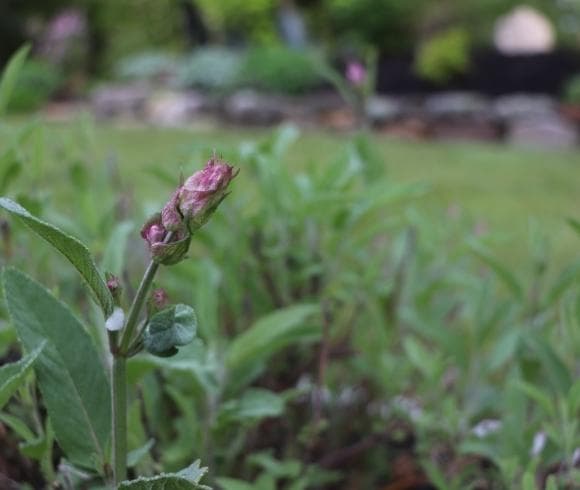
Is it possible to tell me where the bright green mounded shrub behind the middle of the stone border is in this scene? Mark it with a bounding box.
[241,46,322,94]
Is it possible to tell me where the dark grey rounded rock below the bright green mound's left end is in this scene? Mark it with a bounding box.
[223,90,287,126]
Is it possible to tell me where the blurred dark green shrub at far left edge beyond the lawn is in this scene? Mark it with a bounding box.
[8,60,62,112]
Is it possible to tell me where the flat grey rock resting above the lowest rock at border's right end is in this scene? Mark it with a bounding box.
[493,94,558,122]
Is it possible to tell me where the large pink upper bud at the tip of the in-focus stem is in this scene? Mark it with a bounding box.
[161,157,238,233]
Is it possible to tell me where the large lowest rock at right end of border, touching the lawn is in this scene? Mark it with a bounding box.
[507,116,578,149]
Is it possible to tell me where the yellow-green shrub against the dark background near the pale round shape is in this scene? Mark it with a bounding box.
[415,28,470,83]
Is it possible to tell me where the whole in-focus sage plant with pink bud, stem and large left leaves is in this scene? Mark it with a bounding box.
[0,155,237,489]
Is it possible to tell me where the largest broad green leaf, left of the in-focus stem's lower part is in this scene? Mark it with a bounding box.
[2,268,111,470]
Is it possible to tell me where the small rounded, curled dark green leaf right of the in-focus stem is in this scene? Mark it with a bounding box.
[143,305,197,356]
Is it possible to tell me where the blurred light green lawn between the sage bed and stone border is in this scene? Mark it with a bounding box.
[0,118,580,268]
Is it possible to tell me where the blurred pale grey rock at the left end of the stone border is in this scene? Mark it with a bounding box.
[90,84,150,118]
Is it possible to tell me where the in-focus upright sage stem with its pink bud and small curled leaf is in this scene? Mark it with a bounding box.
[106,156,237,484]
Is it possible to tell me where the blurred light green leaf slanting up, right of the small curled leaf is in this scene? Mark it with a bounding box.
[226,304,320,372]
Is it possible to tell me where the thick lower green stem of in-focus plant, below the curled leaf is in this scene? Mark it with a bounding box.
[112,355,127,488]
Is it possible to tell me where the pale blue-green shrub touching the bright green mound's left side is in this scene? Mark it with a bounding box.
[176,47,243,91]
